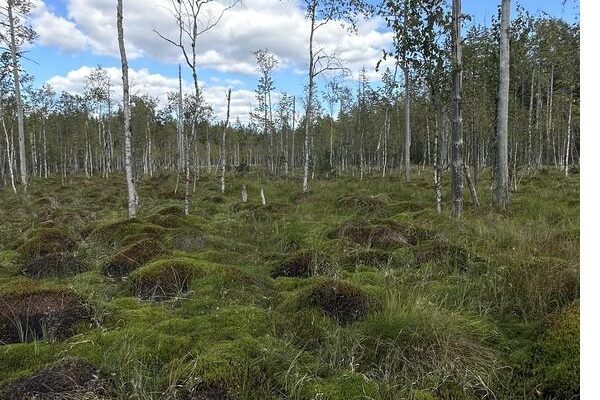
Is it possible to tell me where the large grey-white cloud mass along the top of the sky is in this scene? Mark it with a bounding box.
[34,0,392,80]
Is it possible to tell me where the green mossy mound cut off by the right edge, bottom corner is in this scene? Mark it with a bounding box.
[532,303,579,399]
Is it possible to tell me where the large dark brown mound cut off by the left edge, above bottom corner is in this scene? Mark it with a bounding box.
[0,289,88,344]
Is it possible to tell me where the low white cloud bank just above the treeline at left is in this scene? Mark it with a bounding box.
[47,66,255,121]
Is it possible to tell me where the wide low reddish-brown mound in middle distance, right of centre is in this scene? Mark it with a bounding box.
[329,220,430,248]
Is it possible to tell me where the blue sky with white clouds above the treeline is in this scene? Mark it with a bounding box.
[18,0,579,122]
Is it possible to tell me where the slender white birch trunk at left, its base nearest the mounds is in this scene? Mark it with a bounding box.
[117,0,137,218]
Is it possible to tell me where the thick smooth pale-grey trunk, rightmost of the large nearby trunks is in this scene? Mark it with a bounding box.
[496,0,510,210]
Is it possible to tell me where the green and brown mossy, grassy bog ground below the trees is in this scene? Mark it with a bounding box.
[0,170,579,400]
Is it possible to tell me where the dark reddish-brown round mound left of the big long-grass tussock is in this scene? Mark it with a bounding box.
[306,279,369,325]
